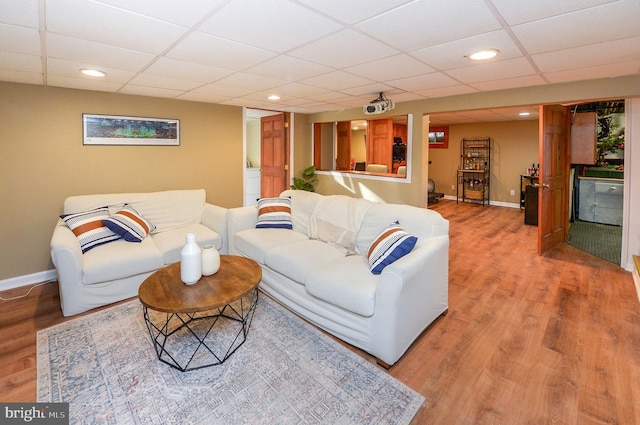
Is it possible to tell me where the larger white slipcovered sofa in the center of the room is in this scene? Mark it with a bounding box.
[227,190,449,367]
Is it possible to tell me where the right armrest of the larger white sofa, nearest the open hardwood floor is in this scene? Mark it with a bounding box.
[372,235,449,365]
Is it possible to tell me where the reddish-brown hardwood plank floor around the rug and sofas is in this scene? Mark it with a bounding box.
[0,200,640,424]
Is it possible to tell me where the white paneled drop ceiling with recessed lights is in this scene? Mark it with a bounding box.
[0,0,640,120]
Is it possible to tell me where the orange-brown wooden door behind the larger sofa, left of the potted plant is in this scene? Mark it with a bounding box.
[260,114,288,198]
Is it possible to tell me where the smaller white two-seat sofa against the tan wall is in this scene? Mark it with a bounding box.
[51,189,227,316]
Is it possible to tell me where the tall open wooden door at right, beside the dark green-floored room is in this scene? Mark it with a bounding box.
[538,105,570,254]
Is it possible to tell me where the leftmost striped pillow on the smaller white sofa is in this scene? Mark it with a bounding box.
[60,207,120,254]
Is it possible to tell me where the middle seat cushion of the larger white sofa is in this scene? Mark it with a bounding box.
[264,238,344,285]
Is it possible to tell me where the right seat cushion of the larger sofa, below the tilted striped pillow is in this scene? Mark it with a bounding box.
[305,255,380,317]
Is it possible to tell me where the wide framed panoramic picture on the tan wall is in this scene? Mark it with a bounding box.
[82,114,180,146]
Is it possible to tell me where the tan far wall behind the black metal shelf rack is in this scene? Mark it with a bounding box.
[429,120,540,204]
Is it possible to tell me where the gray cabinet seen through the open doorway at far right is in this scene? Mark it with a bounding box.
[578,178,624,226]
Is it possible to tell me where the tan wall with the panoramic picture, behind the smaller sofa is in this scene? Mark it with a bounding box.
[0,82,244,280]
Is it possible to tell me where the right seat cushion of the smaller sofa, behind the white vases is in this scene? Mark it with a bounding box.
[151,224,222,264]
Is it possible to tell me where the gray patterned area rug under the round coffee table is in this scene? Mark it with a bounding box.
[37,294,424,425]
